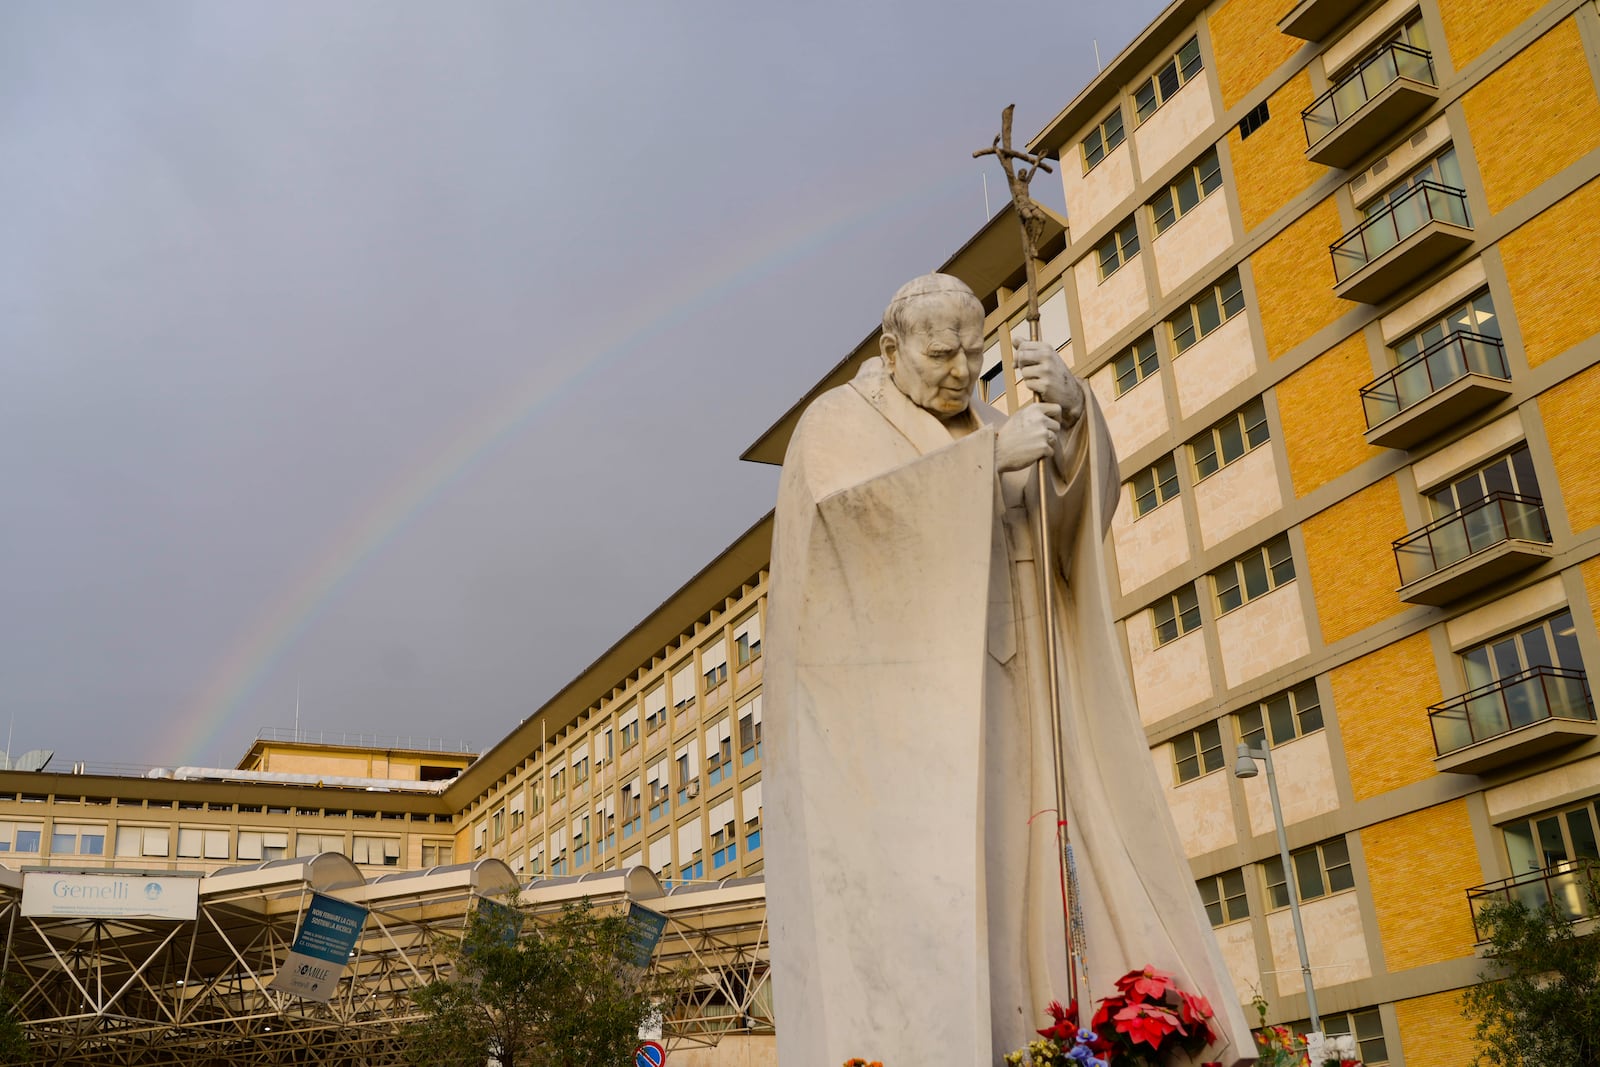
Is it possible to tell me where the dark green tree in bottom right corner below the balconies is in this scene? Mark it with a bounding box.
[1462,869,1600,1067]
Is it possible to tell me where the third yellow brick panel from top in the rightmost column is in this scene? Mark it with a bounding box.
[1501,181,1600,366]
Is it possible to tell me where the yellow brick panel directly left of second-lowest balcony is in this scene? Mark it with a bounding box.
[1330,633,1440,800]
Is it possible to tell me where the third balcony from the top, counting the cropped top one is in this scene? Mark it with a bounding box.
[1328,181,1472,304]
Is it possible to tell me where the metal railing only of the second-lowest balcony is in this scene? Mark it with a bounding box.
[1427,667,1595,757]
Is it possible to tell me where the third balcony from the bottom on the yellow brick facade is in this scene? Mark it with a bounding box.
[1394,493,1552,606]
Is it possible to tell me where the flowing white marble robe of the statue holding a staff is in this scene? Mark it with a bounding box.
[763,358,1254,1067]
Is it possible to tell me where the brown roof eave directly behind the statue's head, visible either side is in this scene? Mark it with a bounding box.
[739,203,1067,467]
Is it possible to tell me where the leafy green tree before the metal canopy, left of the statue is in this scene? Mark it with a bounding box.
[405,901,666,1067]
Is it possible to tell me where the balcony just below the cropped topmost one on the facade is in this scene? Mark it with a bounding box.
[1301,42,1438,168]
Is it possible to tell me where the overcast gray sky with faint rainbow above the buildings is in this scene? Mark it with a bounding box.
[0,0,1162,766]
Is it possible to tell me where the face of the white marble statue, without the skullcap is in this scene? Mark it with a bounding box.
[882,293,984,419]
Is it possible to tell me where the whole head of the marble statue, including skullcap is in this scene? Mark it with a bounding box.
[878,274,984,419]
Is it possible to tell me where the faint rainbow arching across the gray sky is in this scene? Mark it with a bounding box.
[172,167,973,765]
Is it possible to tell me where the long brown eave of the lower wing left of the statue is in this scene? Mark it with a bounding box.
[443,512,773,813]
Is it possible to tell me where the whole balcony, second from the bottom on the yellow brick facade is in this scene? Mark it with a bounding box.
[1427,667,1600,774]
